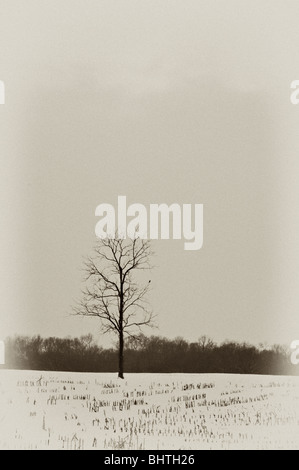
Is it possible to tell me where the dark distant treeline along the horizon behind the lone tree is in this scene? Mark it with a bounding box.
[1,335,299,375]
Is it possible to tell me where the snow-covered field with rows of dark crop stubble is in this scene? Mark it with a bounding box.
[0,371,299,450]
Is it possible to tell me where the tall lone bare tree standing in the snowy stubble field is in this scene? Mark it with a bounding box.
[75,238,154,379]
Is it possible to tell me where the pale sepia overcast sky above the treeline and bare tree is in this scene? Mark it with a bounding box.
[0,0,299,344]
